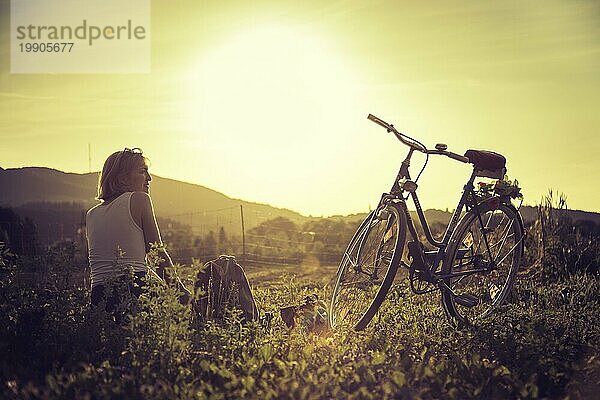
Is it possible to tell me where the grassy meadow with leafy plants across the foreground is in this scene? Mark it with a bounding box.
[0,248,600,399]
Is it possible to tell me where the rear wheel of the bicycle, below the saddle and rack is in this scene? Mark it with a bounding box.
[442,203,524,324]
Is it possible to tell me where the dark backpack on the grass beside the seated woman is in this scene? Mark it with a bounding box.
[194,255,258,321]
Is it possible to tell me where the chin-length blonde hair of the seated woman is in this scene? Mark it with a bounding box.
[96,147,148,201]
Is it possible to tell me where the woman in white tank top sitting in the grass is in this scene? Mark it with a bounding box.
[86,148,189,313]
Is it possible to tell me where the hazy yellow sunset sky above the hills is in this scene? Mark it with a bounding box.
[0,0,600,216]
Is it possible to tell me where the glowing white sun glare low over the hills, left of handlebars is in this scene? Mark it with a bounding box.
[186,22,365,209]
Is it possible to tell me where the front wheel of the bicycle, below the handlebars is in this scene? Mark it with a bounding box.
[329,203,406,331]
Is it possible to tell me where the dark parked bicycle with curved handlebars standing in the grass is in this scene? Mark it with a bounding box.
[329,114,525,331]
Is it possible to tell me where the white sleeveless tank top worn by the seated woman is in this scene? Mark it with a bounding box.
[86,192,146,288]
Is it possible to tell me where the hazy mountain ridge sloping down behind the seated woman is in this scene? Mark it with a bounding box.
[0,167,309,241]
